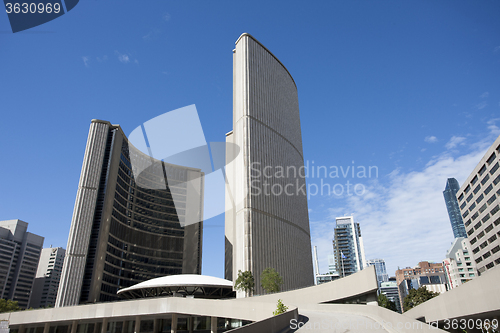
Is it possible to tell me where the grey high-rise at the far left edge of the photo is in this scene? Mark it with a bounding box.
[0,220,44,308]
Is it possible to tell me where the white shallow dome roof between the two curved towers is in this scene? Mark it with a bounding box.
[118,274,233,294]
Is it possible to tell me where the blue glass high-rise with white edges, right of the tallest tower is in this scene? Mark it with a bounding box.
[333,216,366,277]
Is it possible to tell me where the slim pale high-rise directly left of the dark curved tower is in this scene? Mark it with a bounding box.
[29,247,66,309]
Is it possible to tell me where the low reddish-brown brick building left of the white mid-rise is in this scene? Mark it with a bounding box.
[396,261,446,311]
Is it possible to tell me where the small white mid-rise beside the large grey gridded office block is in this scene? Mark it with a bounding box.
[443,237,477,290]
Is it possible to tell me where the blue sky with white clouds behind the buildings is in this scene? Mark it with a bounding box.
[0,0,500,277]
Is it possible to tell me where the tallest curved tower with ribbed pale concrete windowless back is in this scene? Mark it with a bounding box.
[225,33,314,296]
